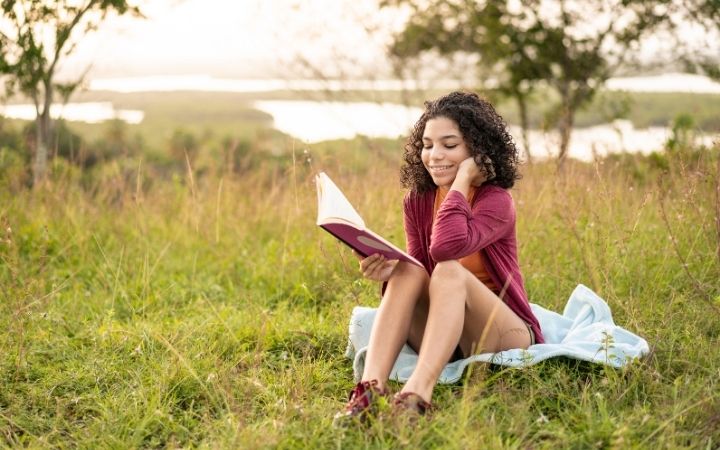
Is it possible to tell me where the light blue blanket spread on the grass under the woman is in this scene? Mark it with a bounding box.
[346,284,649,383]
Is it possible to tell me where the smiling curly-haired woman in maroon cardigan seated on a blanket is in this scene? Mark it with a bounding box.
[336,92,543,419]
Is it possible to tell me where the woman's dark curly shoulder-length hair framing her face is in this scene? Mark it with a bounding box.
[400,91,520,193]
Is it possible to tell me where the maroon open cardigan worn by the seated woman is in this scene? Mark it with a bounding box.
[403,184,545,344]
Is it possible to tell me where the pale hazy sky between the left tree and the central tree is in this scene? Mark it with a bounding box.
[63,0,399,77]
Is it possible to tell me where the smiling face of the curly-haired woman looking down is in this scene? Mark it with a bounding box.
[420,117,470,188]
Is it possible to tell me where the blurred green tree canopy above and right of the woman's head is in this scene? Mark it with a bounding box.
[383,0,675,164]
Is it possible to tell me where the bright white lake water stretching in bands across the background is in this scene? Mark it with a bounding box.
[0,74,720,161]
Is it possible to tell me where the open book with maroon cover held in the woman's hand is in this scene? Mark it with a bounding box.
[315,172,423,267]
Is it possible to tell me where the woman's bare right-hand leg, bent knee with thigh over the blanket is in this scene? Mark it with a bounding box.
[402,261,530,401]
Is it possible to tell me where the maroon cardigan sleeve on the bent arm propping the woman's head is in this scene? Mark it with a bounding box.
[430,186,515,261]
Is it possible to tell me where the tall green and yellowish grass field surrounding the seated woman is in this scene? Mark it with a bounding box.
[0,133,720,449]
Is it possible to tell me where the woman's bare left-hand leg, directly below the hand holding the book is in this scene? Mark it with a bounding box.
[362,261,430,389]
